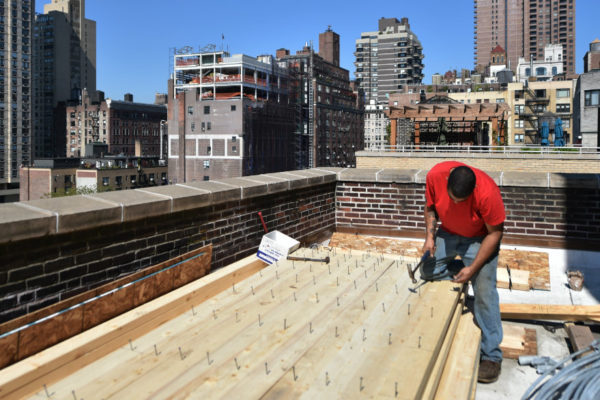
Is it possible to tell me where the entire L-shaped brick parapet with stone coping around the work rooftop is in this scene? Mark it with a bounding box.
[0,168,600,321]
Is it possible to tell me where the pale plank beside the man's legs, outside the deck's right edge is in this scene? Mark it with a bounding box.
[435,313,481,400]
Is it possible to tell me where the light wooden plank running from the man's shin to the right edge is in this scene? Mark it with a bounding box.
[500,303,600,322]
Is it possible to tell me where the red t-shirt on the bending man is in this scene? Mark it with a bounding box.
[425,161,506,237]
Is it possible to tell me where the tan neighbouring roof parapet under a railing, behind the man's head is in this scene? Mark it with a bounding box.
[356,151,600,173]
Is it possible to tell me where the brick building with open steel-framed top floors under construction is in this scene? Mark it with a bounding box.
[168,51,294,182]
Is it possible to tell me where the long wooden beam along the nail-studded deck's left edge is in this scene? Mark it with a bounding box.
[0,256,265,399]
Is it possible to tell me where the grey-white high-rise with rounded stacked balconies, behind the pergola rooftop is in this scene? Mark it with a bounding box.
[354,18,424,147]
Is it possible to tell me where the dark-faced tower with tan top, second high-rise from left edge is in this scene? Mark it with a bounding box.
[34,0,96,158]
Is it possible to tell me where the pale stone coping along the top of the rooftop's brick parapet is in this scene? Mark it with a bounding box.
[0,168,600,243]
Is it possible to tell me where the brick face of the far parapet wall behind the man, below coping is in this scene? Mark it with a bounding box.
[336,182,600,245]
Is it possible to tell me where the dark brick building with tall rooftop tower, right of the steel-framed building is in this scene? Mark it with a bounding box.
[276,28,364,169]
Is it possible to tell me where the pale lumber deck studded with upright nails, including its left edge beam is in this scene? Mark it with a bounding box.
[0,249,476,399]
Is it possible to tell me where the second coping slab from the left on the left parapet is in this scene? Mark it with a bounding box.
[23,196,121,236]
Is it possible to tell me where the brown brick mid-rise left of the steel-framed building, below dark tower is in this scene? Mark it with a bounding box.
[66,89,167,157]
